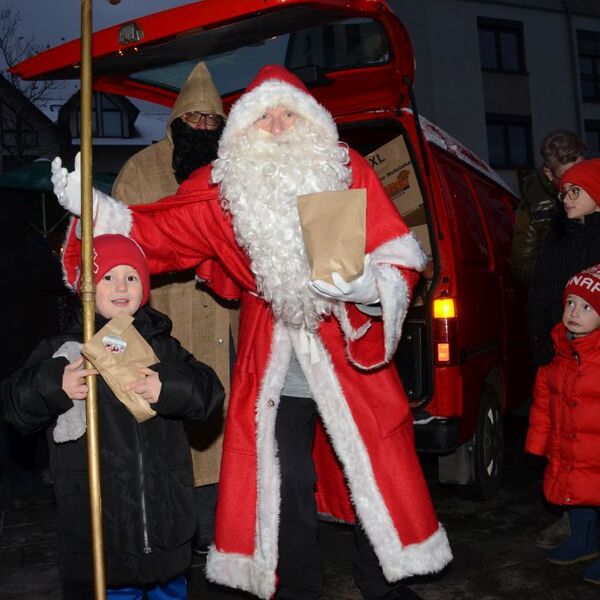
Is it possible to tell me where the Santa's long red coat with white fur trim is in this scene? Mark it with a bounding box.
[65,151,452,598]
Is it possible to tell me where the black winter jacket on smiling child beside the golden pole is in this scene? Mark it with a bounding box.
[0,307,224,587]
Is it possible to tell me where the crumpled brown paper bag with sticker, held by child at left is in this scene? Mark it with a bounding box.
[81,311,160,423]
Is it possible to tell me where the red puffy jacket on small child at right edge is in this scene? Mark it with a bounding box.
[525,323,600,506]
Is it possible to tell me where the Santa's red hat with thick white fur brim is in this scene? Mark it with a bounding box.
[221,65,338,145]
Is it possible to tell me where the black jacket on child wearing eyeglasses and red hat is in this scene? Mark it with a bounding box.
[527,212,600,366]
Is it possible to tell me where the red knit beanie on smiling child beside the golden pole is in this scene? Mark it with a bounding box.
[63,233,150,306]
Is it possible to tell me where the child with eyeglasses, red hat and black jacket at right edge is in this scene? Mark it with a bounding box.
[527,159,600,367]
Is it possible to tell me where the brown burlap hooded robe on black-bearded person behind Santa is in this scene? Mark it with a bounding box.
[112,67,239,486]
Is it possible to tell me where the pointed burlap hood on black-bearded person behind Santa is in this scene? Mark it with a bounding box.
[167,62,225,143]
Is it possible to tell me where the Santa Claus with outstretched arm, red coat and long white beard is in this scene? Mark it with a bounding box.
[53,66,451,600]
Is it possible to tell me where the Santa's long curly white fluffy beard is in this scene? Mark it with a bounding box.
[212,119,352,331]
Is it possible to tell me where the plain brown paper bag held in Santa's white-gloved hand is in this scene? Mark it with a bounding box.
[298,189,367,283]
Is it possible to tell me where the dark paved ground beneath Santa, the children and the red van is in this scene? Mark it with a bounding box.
[0,417,600,600]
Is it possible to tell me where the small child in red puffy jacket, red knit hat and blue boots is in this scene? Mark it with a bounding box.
[525,265,600,585]
